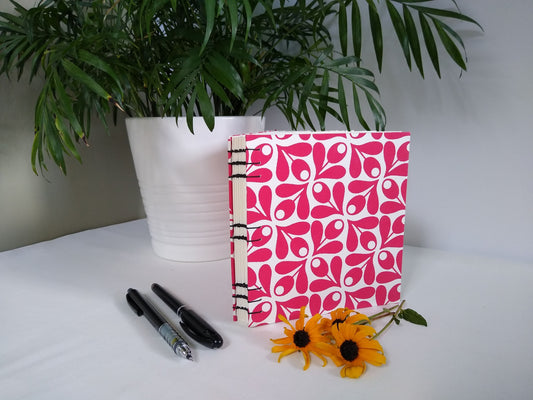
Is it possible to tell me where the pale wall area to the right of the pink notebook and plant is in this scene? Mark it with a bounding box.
[267,0,533,260]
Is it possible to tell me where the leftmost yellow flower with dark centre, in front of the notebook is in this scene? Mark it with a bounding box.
[271,307,331,370]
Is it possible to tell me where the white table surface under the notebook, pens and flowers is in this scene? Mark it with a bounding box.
[0,220,533,400]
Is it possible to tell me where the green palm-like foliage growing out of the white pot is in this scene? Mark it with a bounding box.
[0,0,478,260]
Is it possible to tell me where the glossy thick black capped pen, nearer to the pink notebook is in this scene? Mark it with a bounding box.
[152,283,223,349]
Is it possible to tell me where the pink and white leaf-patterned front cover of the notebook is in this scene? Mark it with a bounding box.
[230,132,410,326]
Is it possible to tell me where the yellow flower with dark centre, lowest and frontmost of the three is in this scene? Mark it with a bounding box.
[329,315,386,378]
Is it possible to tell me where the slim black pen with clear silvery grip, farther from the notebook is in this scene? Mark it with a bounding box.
[126,289,192,360]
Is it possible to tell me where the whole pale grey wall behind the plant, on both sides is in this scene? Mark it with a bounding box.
[0,0,533,261]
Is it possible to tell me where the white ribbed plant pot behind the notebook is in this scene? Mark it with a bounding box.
[126,117,264,261]
